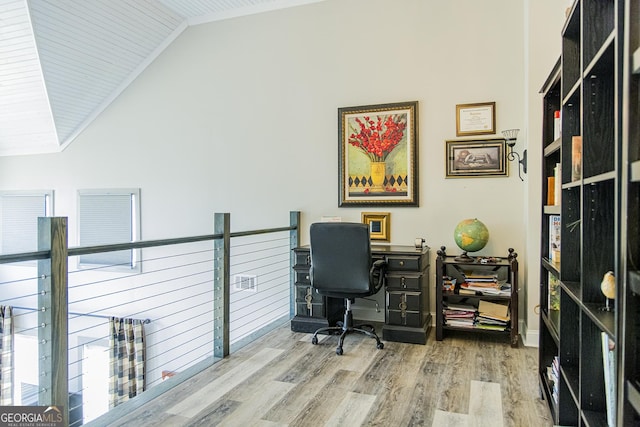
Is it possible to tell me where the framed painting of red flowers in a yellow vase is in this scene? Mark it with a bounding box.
[338,101,418,206]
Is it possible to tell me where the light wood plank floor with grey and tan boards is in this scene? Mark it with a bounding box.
[102,324,552,427]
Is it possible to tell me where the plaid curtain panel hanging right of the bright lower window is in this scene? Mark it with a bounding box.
[109,317,146,408]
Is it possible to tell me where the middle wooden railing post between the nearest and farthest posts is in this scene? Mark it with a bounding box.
[213,213,231,358]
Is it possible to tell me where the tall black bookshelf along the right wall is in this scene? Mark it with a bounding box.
[539,0,626,426]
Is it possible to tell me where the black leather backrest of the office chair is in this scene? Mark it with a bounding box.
[309,222,373,297]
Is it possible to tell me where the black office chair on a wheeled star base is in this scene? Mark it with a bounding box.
[309,222,387,355]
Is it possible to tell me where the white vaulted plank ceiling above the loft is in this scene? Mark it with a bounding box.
[0,0,322,156]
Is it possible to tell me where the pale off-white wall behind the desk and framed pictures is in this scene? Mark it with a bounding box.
[0,0,565,346]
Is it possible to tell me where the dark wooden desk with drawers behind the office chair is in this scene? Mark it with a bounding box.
[291,245,431,344]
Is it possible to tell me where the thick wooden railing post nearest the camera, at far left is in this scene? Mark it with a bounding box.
[38,217,69,425]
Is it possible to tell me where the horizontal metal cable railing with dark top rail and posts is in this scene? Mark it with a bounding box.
[0,212,299,426]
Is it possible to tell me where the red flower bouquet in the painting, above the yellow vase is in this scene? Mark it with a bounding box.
[349,114,407,162]
